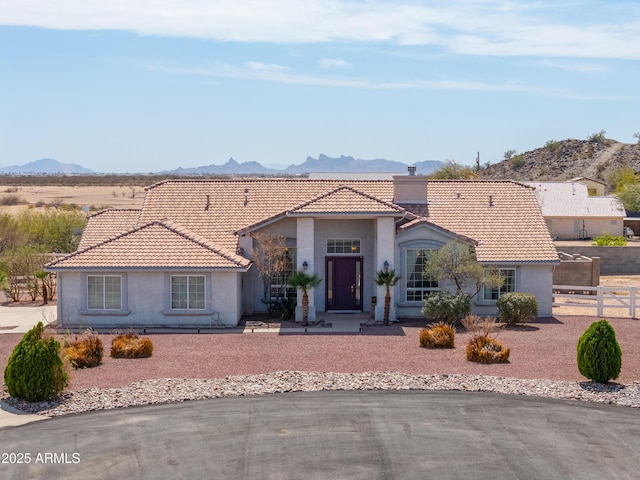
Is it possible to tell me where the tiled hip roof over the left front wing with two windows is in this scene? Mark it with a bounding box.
[47,221,251,271]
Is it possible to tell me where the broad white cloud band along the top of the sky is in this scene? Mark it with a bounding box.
[0,0,640,60]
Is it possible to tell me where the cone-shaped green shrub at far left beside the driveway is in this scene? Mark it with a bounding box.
[4,322,68,402]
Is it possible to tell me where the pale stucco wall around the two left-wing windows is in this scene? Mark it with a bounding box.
[58,271,242,329]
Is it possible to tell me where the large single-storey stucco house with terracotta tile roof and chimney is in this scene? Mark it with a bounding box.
[47,175,559,328]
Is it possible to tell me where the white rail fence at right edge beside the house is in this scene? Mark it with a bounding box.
[553,285,640,318]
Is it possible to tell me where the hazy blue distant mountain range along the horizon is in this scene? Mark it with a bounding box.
[0,153,445,175]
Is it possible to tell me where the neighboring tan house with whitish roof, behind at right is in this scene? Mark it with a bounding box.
[525,182,625,240]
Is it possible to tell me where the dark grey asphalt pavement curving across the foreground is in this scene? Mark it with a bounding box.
[0,391,640,480]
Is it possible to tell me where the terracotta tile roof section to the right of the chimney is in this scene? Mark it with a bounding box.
[428,181,558,263]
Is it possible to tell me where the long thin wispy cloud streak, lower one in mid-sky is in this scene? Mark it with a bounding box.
[146,62,640,100]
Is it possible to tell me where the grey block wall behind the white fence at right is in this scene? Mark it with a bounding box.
[554,244,640,274]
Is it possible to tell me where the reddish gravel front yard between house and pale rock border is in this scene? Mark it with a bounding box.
[0,316,640,390]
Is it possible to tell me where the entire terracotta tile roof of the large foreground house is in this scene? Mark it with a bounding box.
[61,179,558,268]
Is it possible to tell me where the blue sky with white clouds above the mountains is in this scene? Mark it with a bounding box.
[0,0,640,172]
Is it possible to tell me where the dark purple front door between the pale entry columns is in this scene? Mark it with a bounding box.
[325,257,362,310]
